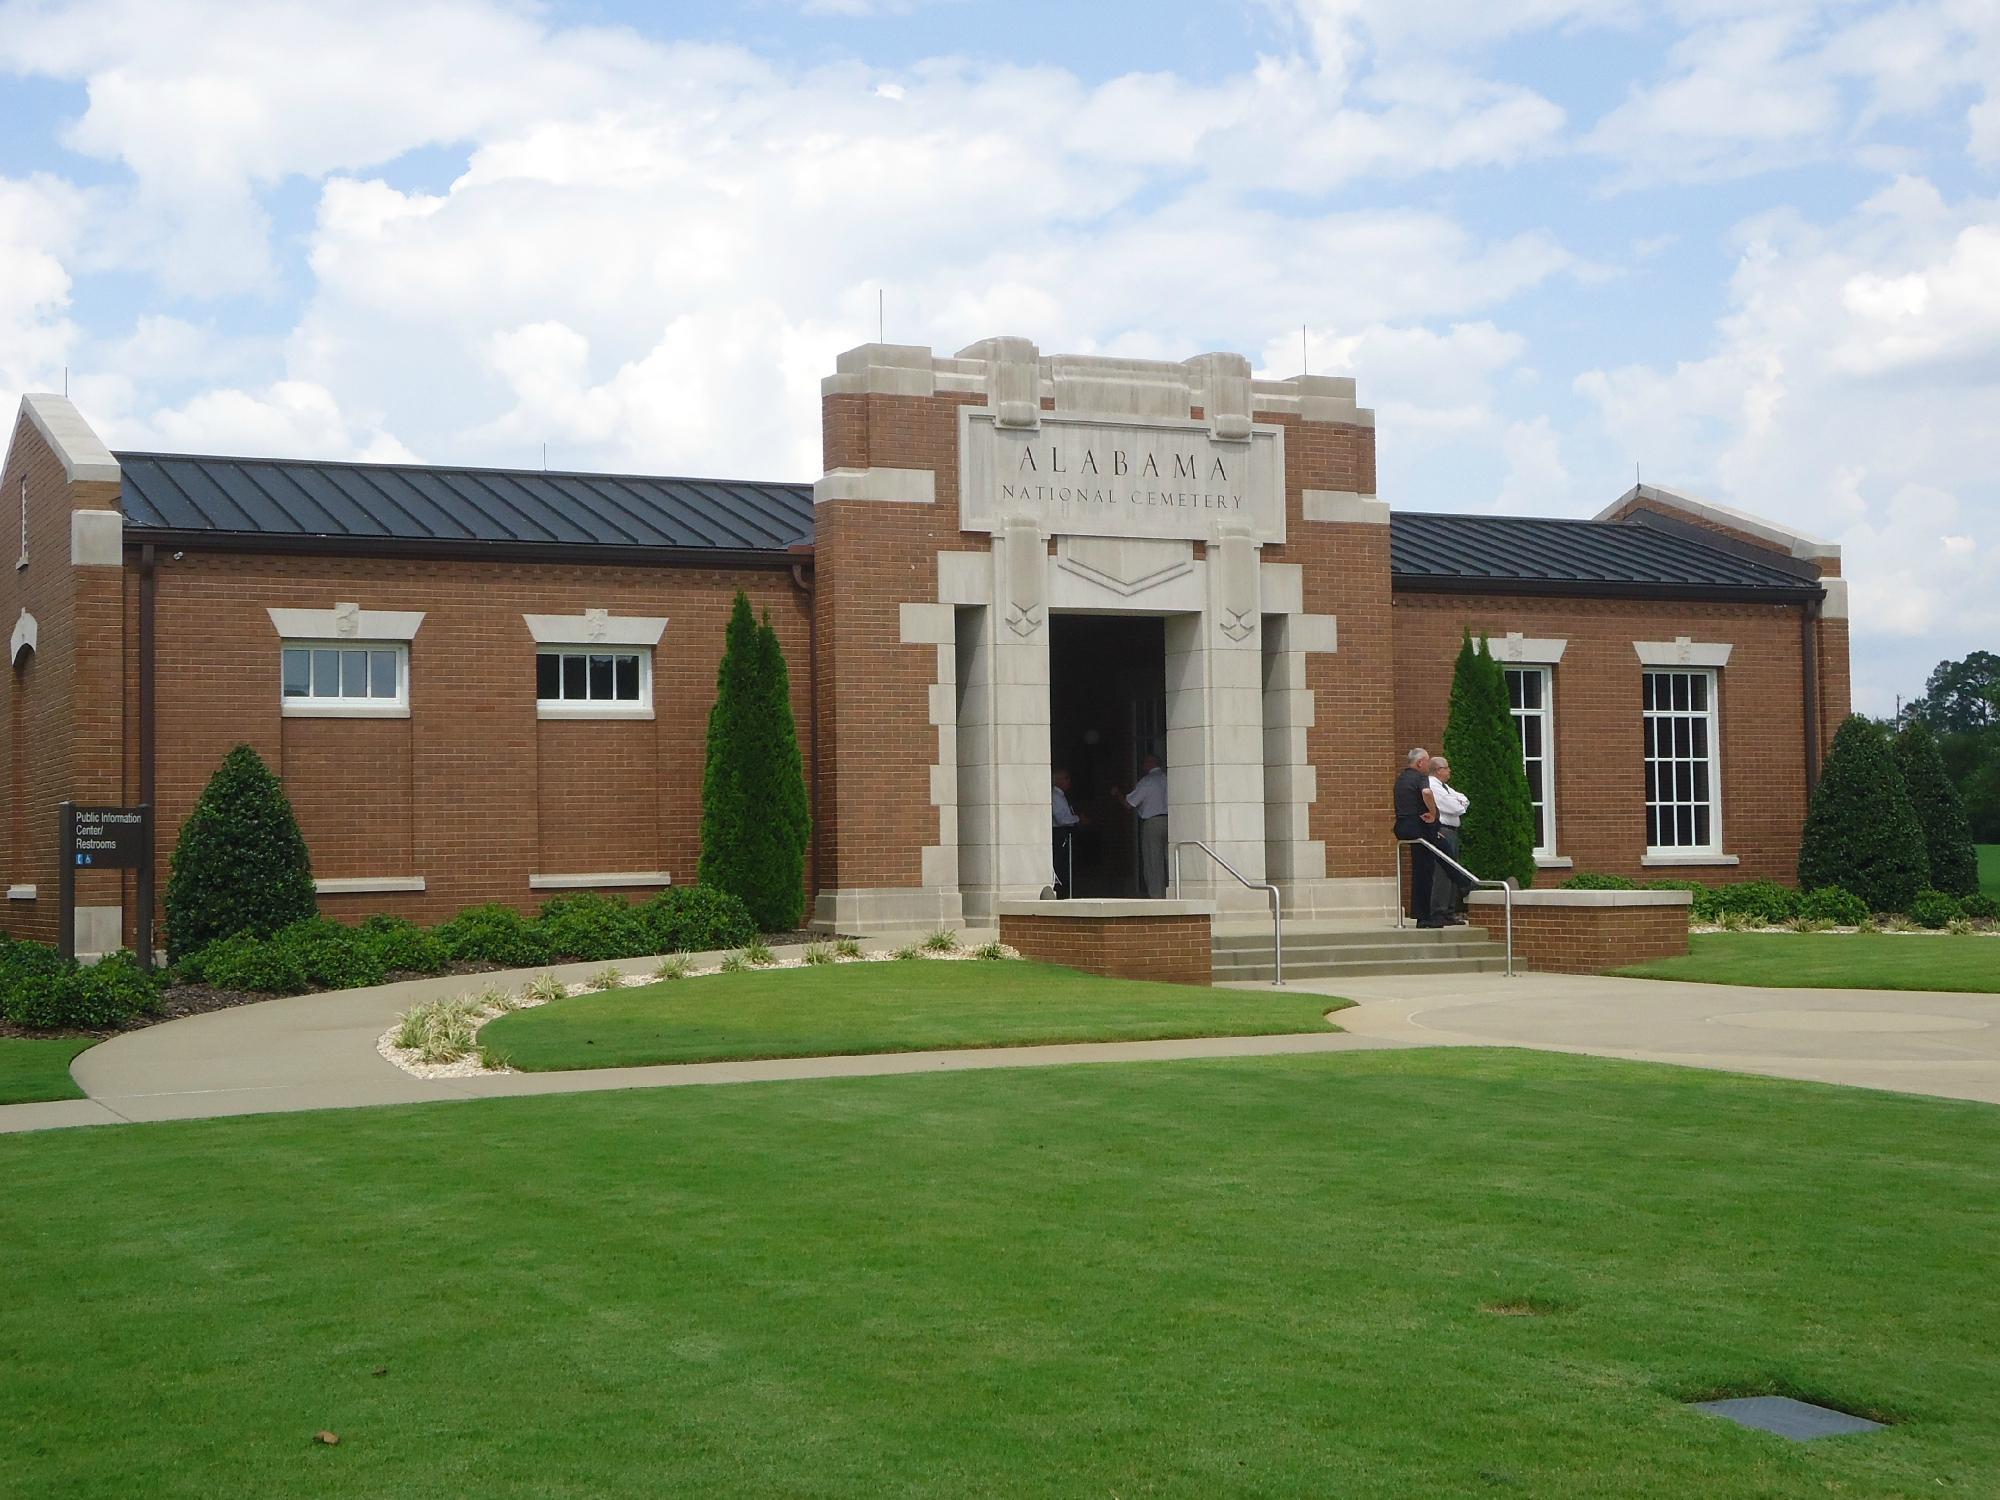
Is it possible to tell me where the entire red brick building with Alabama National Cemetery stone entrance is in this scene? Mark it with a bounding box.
[0,338,1848,952]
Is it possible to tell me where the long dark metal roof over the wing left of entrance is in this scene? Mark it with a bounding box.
[116,454,812,552]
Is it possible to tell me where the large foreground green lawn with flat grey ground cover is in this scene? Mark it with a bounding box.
[0,1050,2000,1500]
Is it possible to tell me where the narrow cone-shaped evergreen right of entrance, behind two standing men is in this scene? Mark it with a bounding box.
[1444,634,1534,886]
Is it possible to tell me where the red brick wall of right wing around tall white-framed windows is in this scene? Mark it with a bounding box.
[1392,594,1846,884]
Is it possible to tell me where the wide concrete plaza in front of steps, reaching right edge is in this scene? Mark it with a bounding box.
[1240,974,2000,1104]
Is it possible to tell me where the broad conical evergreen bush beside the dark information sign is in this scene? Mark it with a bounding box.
[166,744,320,958]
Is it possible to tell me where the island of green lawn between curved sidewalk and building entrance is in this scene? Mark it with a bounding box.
[480,960,1350,1072]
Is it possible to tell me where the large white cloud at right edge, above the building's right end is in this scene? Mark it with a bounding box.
[1576,182,2000,708]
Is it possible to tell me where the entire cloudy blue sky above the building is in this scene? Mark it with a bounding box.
[0,0,2000,710]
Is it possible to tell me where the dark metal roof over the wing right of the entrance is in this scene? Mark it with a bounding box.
[1390,512,1820,598]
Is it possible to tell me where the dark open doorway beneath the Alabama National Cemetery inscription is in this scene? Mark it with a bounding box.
[1048,614,1166,896]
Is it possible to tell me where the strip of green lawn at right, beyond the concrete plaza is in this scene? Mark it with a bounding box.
[1618,932,2000,994]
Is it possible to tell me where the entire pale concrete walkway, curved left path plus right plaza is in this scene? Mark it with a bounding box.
[0,960,2000,1132]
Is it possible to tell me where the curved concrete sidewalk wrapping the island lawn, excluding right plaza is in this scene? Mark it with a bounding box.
[0,950,1398,1132]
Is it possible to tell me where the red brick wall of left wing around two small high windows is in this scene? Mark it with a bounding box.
[8,548,812,938]
